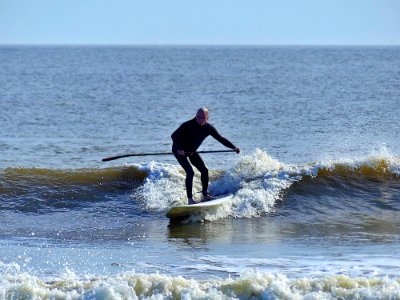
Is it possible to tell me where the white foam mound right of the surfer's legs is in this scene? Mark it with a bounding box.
[198,149,298,220]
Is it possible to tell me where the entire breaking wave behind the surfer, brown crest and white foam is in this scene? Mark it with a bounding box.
[0,150,400,222]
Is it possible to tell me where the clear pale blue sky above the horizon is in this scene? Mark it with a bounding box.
[0,0,400,45]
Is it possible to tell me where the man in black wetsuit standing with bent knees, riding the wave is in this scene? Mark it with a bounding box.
[171,107,240,204]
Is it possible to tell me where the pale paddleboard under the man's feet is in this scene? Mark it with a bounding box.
[166,194,233,219]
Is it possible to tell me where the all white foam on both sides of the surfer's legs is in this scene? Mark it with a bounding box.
[134,149,304,221]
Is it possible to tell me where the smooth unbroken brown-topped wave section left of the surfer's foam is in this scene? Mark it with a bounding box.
[0,167,145,213]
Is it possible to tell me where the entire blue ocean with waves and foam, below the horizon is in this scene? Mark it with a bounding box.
[0,45,400,299]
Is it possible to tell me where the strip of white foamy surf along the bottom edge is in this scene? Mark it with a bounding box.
[0,264,400,299]
